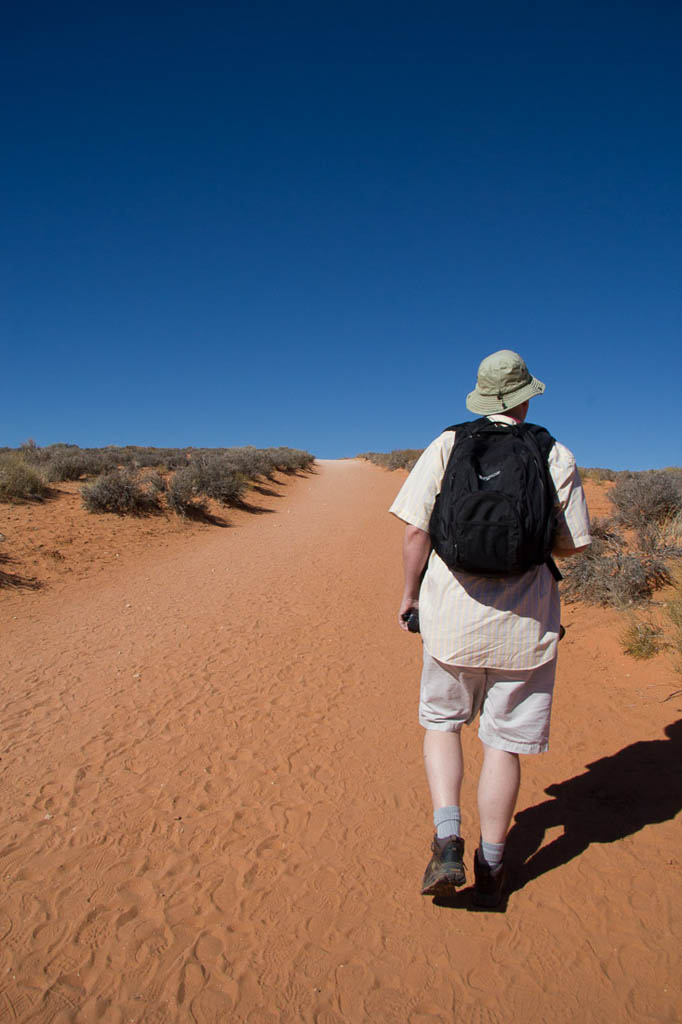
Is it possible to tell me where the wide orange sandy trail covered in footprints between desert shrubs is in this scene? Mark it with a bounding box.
[0,461,682,1024]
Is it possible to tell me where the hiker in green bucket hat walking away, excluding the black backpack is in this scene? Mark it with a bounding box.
[390,349,591,906]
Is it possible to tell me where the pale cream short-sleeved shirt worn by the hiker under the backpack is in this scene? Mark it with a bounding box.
[390,416,591,670]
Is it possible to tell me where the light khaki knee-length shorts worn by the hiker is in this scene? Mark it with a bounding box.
[419,647,556,754]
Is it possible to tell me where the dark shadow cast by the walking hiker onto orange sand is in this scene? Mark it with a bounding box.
[506,719,682,892]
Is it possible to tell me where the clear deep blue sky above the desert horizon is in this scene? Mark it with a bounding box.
[0,0,682,469]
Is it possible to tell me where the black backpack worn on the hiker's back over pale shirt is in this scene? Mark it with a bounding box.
[429,417,561,580]
